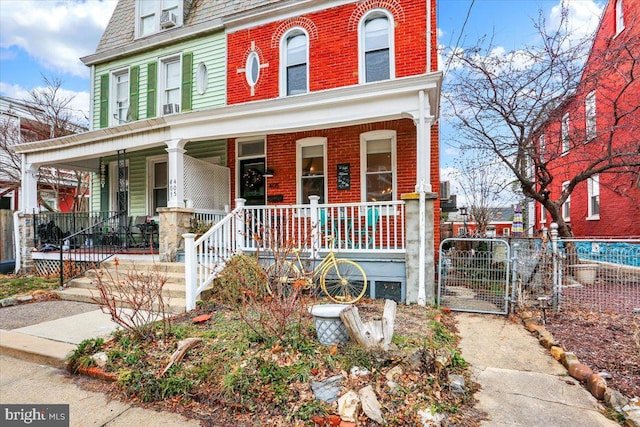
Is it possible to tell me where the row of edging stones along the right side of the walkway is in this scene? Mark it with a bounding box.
[519,310,640,427]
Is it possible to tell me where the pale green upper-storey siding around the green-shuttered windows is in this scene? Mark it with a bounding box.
[93,31,226,127]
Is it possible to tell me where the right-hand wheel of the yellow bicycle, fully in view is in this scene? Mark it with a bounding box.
[320,259,367,304]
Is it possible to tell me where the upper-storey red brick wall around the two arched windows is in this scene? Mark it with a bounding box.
[227,0,428,104]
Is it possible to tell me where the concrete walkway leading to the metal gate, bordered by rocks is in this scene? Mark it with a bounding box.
[455,313,619,427]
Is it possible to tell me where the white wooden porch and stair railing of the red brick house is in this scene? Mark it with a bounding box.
[184,196,406,310]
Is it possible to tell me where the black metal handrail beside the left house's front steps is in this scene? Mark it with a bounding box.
[57,213,128,286]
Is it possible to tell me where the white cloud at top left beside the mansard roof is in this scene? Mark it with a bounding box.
[0,0,117,78]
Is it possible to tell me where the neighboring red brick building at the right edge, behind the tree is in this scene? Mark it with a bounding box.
[536,0,640,237]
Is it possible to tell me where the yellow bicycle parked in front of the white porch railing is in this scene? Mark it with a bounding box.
[267,236,367,304]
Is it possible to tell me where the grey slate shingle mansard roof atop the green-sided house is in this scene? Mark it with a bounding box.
[95,0,290,54]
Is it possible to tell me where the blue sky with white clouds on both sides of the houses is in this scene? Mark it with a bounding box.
[0,0,605,202]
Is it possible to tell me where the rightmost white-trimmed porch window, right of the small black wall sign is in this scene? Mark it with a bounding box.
[360,130,396,202]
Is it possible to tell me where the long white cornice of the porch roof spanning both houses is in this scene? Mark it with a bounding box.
[15,72,442,165]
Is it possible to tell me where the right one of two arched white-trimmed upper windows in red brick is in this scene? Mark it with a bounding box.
[359,9,395,83]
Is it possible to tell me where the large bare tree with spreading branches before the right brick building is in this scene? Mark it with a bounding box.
[444,10,640,241]
